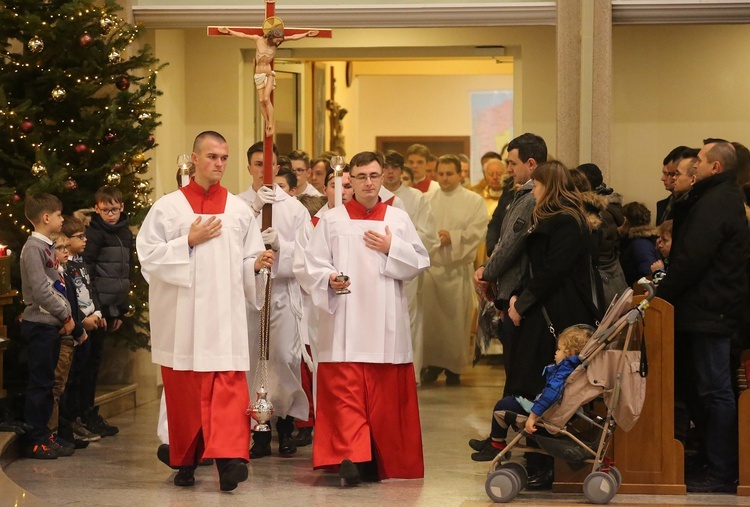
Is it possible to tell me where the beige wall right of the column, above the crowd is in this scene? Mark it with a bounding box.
[609,25,750,216]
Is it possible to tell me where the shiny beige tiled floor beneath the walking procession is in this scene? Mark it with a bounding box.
[0,364,750,507]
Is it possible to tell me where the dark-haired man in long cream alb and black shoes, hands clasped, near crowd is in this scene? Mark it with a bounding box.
[422,155,488,385]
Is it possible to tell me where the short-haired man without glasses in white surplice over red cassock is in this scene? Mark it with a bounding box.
[136,131,274,491]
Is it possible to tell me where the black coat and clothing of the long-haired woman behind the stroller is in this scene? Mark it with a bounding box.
[505,214,601,400]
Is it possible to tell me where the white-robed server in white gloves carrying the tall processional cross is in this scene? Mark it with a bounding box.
[239,142,310,458]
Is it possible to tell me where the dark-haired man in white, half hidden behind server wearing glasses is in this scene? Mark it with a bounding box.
[381,151,440,384]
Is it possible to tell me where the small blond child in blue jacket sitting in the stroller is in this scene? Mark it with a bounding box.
[469,324,594,461]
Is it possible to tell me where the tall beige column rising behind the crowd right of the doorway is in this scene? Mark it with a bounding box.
[551,0,612,180]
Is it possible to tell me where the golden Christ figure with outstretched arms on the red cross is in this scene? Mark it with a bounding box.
[219,21,319,137]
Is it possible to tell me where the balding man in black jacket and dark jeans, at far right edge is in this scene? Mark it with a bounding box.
[657,139,750,492]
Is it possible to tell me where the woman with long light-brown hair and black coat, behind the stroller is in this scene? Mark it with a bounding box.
[505,161,601,489]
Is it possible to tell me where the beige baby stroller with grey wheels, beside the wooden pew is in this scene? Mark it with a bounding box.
[485,279,654,504]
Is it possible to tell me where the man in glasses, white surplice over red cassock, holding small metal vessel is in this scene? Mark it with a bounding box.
[298,152,430,484]
